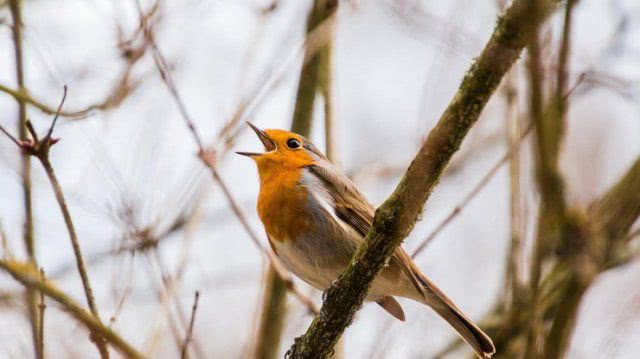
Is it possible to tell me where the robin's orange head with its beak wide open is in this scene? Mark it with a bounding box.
[236,122,324,176]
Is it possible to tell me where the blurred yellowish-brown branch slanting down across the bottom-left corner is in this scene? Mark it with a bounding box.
[0,259,144,359]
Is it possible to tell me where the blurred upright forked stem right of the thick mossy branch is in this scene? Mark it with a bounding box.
[525,0,581,359]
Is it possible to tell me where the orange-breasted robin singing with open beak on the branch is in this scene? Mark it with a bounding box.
[236,122,495,358]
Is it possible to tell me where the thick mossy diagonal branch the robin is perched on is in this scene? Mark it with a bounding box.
[290,1,553,358]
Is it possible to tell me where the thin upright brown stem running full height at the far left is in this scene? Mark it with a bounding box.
[3,0,39,358]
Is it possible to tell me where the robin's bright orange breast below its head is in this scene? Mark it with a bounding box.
[258,168,309,241]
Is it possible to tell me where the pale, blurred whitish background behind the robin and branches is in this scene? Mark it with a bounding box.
[0,0,640,358]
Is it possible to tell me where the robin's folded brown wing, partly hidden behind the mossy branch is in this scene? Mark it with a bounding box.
[309,156,424,302]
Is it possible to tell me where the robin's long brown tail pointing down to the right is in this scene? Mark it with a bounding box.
[416,273,496,359]
